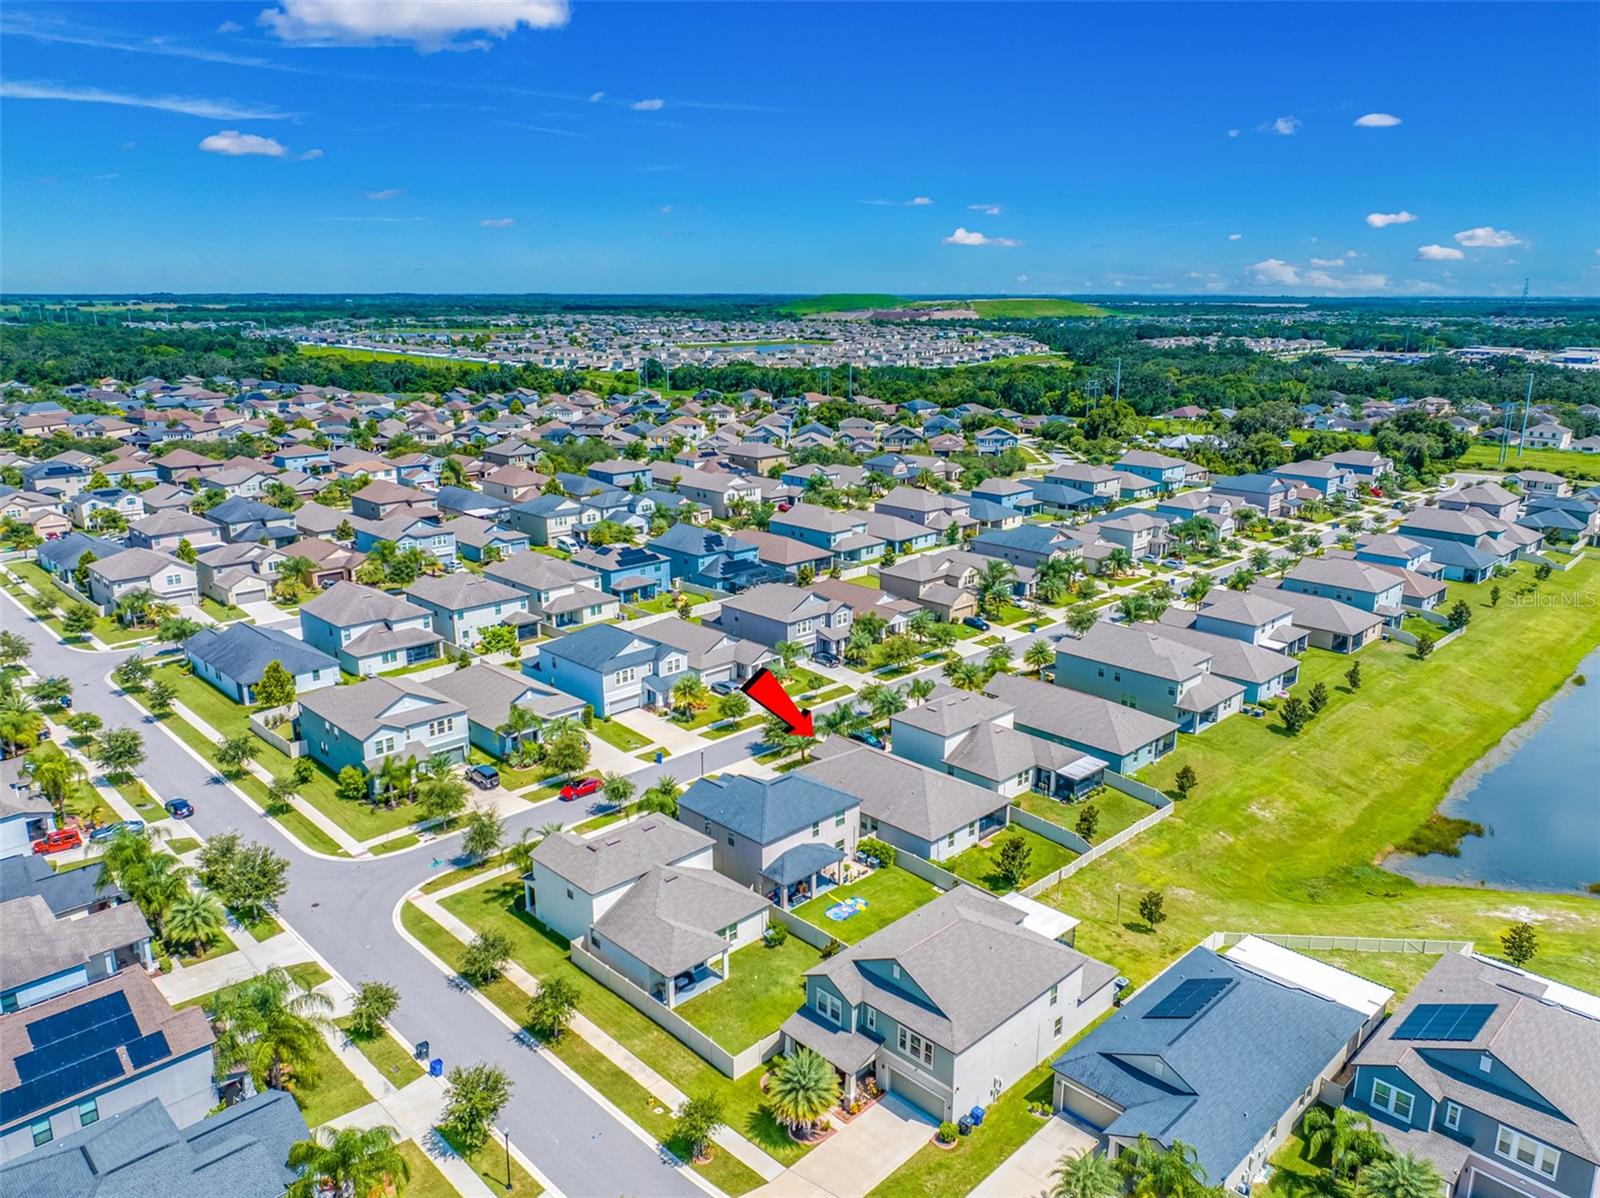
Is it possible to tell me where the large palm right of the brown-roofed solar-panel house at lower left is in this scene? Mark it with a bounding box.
[206,964,333,1089]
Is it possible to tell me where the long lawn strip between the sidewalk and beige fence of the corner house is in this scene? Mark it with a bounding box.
[424,878,806,1170]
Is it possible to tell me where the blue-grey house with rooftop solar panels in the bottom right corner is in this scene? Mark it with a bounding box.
[1346,953,1600,1198]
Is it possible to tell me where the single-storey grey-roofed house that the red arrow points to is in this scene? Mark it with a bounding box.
[795,741,1008,861]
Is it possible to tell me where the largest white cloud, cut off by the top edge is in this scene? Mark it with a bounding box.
[259,0,570,50]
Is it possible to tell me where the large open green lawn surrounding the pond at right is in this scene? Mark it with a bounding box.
[1042,560,1600,992]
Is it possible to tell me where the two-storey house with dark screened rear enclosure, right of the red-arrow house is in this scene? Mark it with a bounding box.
[890,686,1106,801]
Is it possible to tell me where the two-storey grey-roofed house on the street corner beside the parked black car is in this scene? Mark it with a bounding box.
[299,678,467,774]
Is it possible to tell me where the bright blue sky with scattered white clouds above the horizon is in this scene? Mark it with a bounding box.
[0,0,1600,296]
